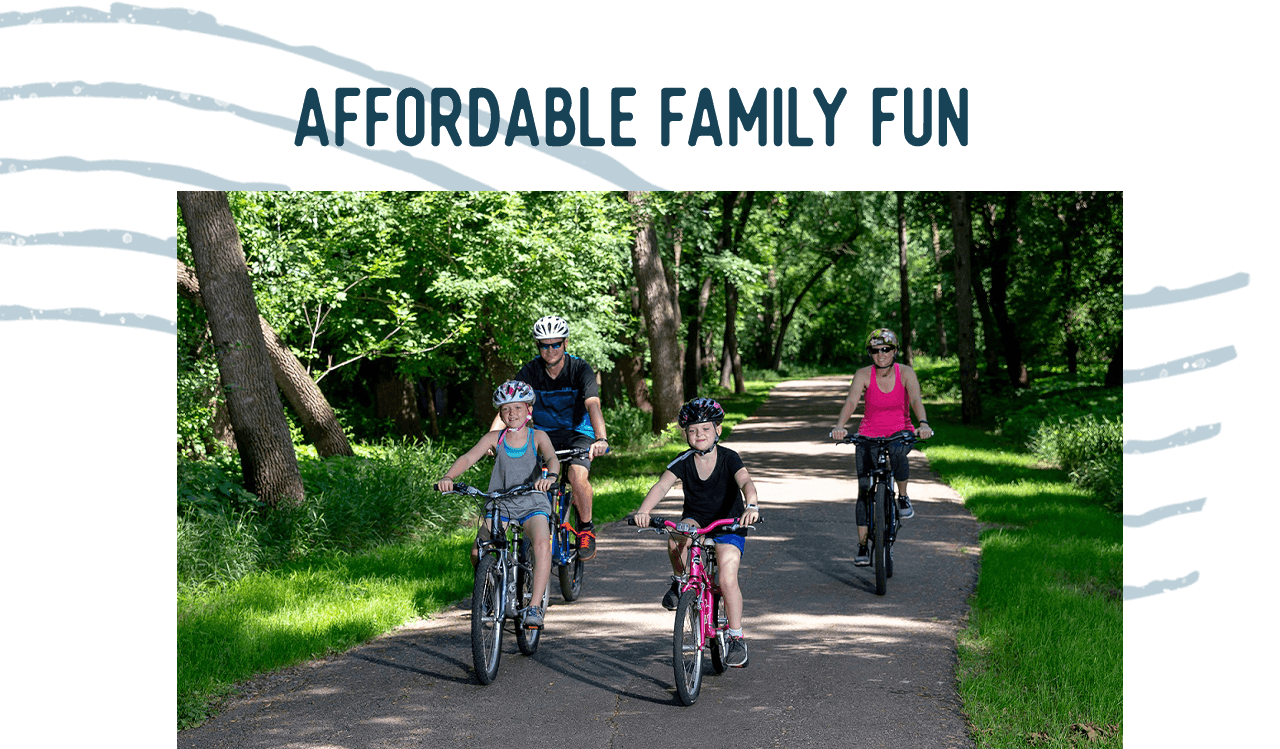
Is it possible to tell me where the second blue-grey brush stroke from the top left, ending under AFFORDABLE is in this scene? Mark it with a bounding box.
[0,81,493,189]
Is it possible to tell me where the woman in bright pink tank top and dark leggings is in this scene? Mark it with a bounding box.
[831,328,933,566]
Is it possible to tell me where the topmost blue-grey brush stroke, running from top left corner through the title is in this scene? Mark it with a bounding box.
[0,3,666,191]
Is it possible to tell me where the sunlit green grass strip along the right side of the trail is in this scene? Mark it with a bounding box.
[928,403,1124,748]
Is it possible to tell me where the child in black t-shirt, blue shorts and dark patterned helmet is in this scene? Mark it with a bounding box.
[635,398,759,668]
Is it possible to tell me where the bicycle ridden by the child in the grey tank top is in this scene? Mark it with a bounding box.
[437,483,550,684]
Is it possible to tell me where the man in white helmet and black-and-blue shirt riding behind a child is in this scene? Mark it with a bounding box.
[494,315,609,562]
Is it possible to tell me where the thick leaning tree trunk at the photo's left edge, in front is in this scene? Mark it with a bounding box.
[178,191,305,506]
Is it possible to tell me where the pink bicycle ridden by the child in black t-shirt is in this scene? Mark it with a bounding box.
[627,516,759,705]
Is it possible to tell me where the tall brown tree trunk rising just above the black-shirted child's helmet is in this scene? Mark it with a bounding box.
[627,191,681,434]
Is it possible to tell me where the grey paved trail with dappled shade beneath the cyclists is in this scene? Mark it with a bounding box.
[177,378,978,749]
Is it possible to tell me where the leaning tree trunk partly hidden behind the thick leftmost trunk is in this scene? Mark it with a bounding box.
[178,260,355,457]
